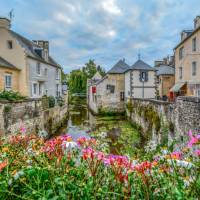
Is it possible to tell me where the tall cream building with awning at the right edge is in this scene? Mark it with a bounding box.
[171,16,200,97]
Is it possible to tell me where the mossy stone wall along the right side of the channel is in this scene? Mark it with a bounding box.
[126,97,200,142]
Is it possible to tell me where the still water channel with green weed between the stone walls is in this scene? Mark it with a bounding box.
[59,98,143,155]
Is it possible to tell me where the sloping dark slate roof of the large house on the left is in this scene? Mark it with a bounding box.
[9,30,60,68]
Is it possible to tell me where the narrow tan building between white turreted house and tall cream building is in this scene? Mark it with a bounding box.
[155,56,175,100]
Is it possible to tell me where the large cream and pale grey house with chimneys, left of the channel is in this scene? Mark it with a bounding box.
[0,18,62,98]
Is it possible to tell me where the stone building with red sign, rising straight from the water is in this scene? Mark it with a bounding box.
[88,59,129,113]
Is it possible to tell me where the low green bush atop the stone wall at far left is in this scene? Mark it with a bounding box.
[0,90,26,101]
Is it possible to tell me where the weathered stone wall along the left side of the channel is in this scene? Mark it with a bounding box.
[0,99,68,135]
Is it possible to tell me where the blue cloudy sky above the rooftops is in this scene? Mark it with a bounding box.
[0,0,200,72]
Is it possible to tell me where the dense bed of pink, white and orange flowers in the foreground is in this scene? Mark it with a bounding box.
[0,131,200,199]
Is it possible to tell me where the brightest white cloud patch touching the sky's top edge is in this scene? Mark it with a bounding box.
[102,0,122,15]
